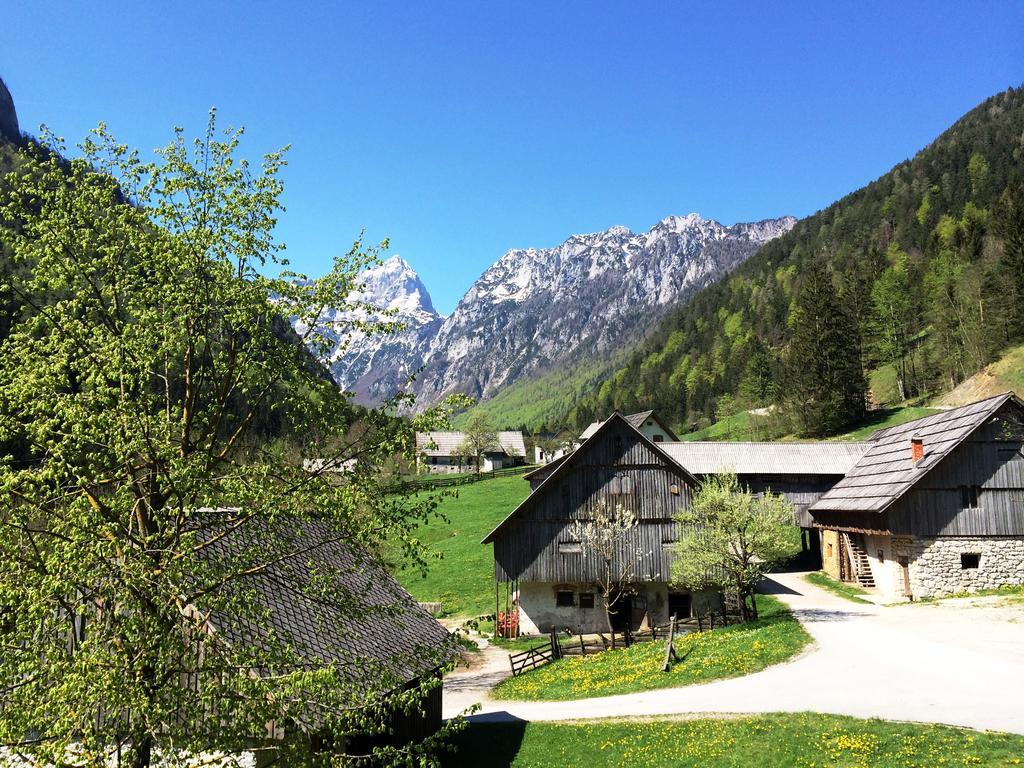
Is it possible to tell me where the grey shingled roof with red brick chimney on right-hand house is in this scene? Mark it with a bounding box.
[810,392,1024,513]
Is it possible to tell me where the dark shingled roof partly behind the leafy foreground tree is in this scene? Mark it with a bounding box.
[199,520,457,690]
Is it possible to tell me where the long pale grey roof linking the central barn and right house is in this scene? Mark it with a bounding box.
[660,440,870,475]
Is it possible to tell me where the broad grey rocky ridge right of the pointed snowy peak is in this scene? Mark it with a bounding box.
[417,214,795,402]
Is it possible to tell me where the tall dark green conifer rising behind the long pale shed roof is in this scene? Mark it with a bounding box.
[782,261,866,435]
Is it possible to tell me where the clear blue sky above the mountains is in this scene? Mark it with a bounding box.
[0,0,1024,312]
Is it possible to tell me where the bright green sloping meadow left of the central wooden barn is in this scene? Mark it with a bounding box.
[395,475,529,617]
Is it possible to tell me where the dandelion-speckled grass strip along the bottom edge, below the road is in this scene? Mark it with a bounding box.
[443,713,1024,768]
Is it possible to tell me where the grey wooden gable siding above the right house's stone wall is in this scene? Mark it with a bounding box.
[890,430,1024,536]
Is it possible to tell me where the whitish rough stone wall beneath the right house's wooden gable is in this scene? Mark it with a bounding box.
[909,537,1024,597]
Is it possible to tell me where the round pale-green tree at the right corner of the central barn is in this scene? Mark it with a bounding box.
[672,474,800,621]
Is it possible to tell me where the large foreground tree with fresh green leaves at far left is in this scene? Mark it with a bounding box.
[0,116,458,768]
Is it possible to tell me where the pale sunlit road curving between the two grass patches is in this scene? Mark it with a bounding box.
[444,573,1024,733]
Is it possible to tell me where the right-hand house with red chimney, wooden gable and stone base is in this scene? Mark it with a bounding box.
[810,392,1024,600]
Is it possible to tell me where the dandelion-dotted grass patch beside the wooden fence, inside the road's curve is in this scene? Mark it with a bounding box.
[494,595,811,701]
